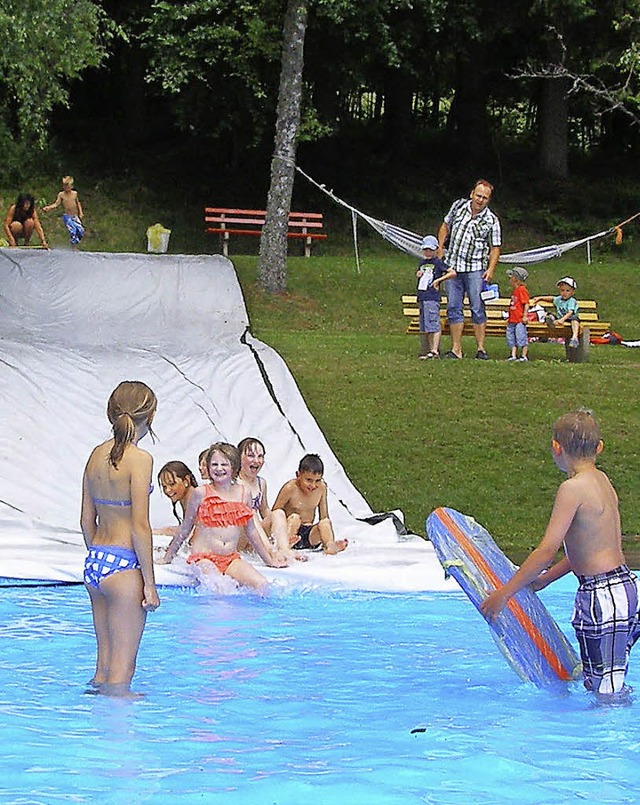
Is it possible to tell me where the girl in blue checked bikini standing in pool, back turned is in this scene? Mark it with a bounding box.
[80,381,160,696]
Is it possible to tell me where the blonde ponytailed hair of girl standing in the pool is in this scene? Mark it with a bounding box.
[107,380,158,467]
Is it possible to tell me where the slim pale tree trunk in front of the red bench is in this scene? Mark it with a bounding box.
[258,0,308,293]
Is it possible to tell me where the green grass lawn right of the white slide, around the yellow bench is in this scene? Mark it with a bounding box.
[233,247,640,564]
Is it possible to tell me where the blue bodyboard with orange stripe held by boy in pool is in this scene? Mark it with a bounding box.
[427,508,581,686]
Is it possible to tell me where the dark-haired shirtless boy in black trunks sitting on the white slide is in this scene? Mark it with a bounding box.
[273,453,348,554]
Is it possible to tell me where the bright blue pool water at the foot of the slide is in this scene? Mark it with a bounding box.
[0,581,640,805]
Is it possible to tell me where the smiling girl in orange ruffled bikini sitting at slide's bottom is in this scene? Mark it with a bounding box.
[156,442,287,591]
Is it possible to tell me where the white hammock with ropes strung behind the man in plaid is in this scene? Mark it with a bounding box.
[295,165,640,273]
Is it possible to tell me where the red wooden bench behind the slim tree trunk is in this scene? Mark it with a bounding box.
[204,207,327,257]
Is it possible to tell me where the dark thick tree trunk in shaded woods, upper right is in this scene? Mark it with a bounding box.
[538,77,571,179]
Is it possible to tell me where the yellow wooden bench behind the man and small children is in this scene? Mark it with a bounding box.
[402,294,611,363]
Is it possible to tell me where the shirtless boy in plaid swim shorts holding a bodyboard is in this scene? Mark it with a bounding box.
[480,411,640,702]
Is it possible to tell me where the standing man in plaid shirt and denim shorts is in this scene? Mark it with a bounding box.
[437,179,502,360]
